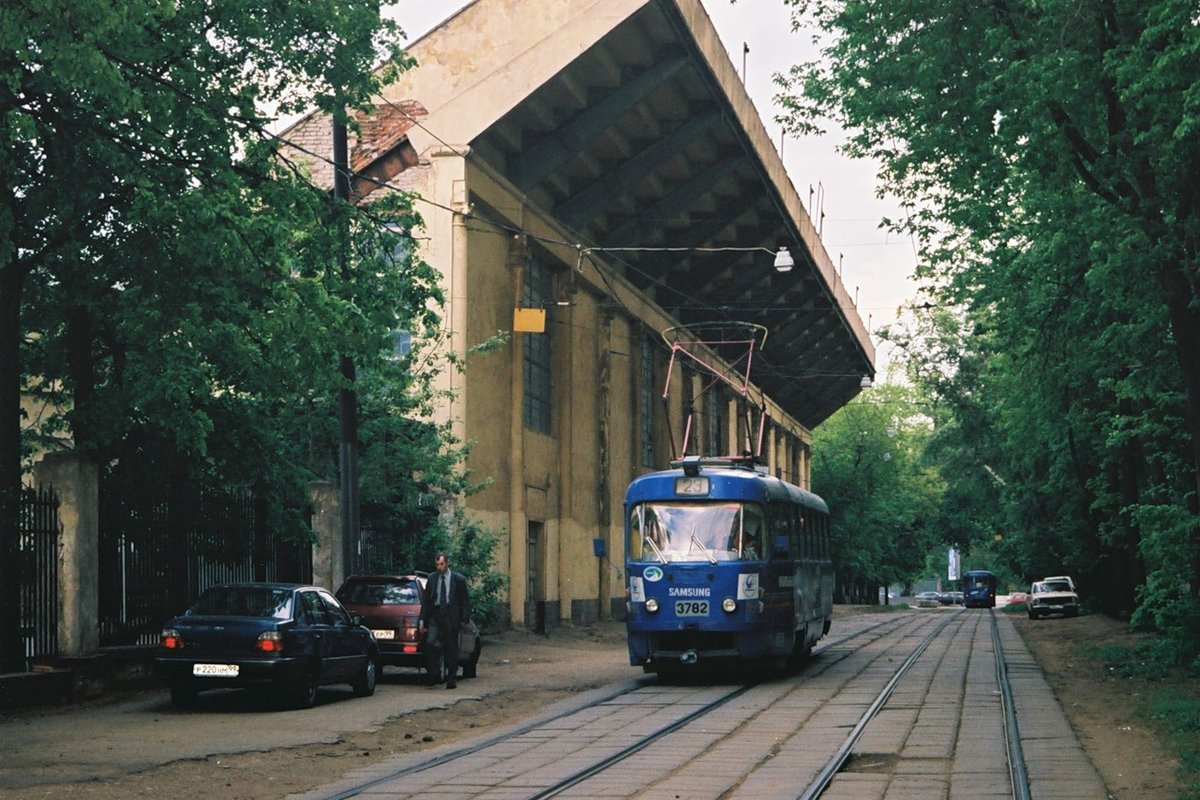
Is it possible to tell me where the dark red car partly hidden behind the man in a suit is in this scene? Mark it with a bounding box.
[337,572,482,678]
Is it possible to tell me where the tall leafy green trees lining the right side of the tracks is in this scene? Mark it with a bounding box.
[780,0,1200,657]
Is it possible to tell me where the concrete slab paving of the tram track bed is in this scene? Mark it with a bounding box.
[296,608,1106,800]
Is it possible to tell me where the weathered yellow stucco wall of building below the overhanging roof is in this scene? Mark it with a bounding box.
[393,155,808,625]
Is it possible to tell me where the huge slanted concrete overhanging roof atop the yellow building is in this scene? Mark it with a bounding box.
[374,0,875,428]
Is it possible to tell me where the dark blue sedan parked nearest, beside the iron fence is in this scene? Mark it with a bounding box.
[155,583,379,708]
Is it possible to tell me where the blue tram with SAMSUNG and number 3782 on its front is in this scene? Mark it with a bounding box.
[625,457,834,672]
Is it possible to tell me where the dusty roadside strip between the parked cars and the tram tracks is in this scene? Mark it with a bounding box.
[0,627,641,794]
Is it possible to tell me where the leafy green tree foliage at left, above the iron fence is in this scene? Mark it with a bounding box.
[0,0,451,668]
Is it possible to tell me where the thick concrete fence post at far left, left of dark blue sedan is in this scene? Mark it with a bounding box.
[34,451,100,657]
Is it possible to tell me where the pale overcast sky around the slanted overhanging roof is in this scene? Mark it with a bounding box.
[390,0,917,379]
